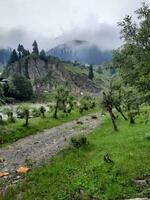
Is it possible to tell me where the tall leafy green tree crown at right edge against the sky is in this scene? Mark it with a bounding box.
[113,3,150,103]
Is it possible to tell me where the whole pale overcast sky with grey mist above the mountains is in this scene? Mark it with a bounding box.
[0,0,150,49]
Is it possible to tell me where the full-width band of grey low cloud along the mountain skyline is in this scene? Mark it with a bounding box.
[0,17,121,50]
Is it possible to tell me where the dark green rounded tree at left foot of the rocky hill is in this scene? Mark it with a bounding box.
[10,74,33,100]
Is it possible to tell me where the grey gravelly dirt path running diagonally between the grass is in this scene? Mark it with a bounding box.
[0,115,100,188]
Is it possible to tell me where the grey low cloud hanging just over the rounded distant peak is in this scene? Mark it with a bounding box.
[54,23,121,50]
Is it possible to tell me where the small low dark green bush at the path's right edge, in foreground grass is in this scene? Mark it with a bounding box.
[71,136,88,148]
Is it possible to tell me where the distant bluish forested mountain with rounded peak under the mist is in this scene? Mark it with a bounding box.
[47,40,112,65]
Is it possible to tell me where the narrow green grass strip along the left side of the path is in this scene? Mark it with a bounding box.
[0,108,98,147]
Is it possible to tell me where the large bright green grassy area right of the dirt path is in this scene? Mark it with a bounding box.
[2,116,150,200]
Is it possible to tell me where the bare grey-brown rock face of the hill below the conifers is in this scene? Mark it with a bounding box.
[3,56,99,93]
